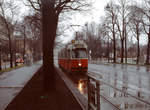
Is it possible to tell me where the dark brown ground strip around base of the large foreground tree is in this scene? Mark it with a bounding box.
[5,69,82,110]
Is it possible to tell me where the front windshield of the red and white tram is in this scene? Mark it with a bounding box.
[72,50,87,58]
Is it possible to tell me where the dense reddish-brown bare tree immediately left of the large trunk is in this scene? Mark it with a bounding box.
[24,12,42,61]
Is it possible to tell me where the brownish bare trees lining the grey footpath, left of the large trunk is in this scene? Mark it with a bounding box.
[0,0,42,70]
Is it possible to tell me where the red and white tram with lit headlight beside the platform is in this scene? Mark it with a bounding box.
[58,40,88,73]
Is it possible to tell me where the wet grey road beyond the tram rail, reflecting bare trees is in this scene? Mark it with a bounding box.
[89,64,150,98]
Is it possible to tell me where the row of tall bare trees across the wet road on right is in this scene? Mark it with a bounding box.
[76,0,150,65]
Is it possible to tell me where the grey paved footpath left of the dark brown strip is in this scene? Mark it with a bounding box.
[0,62,42,110]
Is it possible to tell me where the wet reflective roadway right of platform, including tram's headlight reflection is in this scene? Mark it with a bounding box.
[56,59,150,110]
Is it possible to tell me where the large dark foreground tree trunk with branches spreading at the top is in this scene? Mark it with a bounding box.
[25,0,89,92]
